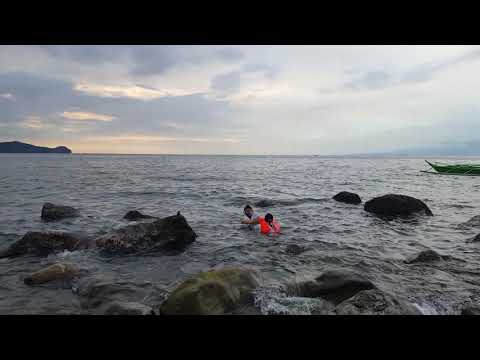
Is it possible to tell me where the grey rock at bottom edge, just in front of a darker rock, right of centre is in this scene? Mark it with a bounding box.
[335,289,422,315]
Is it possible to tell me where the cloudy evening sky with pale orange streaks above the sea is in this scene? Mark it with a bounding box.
[0,45,480,155]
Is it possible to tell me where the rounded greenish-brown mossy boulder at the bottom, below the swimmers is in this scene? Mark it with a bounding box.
[160,268,258,315]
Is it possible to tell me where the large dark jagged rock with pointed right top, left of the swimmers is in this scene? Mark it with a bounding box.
[96,214,197,255]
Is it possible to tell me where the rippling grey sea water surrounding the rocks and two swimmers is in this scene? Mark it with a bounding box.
[0,154,480,314]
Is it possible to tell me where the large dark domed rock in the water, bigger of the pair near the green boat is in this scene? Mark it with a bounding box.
[364,194,433,216]
